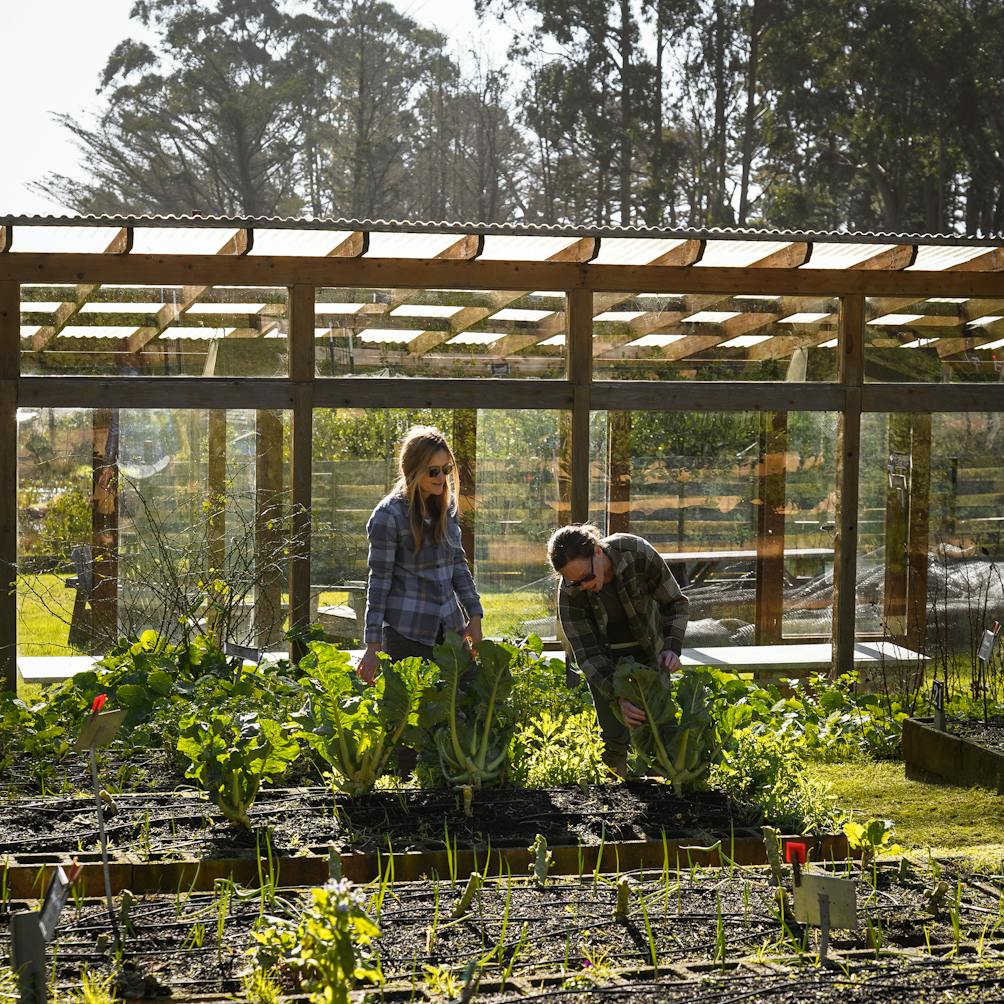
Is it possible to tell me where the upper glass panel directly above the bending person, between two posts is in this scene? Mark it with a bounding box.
[592,292,837,381]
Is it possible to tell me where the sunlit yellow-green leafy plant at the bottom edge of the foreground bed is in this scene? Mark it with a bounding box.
[252,879,384,1004]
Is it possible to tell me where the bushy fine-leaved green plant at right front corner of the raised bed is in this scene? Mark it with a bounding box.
[711,729,839,833]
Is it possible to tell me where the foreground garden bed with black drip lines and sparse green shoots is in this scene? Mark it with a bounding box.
[13,862,1004,1004]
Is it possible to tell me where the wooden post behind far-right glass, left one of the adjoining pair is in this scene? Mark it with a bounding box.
[883,412,912,645]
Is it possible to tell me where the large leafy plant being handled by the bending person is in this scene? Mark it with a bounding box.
[613,659,721,795]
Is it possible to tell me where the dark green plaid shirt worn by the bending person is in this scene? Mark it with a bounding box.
[558,533,690,700]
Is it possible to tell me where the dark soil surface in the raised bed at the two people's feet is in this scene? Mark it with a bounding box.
[0,782,747,857]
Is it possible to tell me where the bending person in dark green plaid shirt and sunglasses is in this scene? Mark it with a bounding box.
[547,523,690,776]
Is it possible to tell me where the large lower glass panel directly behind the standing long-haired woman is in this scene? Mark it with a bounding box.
[311,409,569,643]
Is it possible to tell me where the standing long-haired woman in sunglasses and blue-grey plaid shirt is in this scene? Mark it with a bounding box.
[358,426,484,683]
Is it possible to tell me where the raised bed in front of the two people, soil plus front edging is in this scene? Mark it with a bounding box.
[0,782,847,896]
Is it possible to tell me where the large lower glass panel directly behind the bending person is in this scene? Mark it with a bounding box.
[590,412,836,647]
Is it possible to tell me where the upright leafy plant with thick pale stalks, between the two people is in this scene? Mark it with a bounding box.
[420,632,517,788]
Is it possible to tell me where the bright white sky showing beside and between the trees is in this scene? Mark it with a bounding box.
[0,0,508,216]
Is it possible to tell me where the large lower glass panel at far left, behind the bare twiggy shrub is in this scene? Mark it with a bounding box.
[17,409,290,656]
